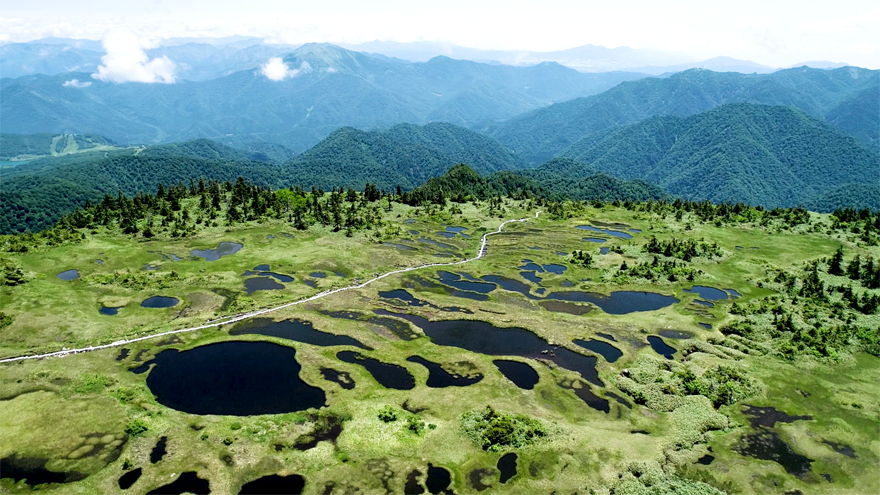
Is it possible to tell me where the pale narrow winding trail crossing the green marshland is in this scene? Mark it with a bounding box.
[0,211,541,364]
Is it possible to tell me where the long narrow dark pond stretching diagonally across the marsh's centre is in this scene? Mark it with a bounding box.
[376,310,604,387]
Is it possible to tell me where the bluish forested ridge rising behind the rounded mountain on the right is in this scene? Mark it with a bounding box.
[489,67,880,163]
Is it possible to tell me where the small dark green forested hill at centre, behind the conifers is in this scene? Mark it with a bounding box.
[287,123,524,190]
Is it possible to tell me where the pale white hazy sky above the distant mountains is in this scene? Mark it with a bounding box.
[0,0,880,69]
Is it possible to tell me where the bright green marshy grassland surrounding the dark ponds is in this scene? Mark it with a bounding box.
[0,200,880,494]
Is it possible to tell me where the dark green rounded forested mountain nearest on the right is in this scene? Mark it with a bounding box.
[563,103,880,207]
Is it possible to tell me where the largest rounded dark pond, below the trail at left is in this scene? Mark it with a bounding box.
[141,342,325,416]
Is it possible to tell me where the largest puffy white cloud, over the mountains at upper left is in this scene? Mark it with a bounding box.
[92,31,177,84]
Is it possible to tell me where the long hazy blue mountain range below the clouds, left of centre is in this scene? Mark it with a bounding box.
[0,44,642,152]
